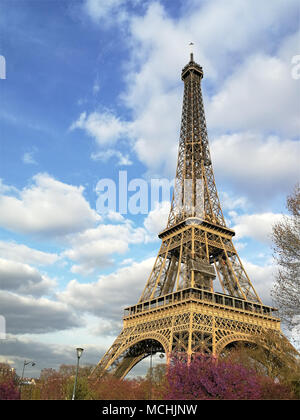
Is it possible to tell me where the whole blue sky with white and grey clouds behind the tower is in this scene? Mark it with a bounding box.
[0,0,300,375]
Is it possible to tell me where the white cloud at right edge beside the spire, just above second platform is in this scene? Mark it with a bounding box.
[211,132,300,201]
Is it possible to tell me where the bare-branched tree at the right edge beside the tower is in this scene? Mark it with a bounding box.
[272,184,300,327]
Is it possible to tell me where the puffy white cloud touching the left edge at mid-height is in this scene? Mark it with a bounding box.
[0,174,100,236]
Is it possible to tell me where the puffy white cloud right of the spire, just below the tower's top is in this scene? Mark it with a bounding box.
[206,50,300,137]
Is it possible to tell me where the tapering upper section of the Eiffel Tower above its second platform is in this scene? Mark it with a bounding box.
[168,51,226,227]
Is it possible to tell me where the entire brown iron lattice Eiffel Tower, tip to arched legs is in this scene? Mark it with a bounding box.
[92,53,280,378]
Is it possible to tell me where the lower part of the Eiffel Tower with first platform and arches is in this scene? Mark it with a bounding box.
[92,288,280,378]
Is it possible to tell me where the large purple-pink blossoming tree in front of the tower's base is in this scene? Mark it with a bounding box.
[165,354,294,400]
